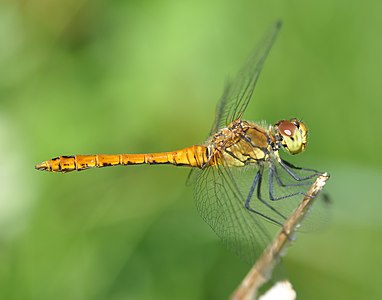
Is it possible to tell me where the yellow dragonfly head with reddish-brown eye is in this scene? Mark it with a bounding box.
[275,118,308,154]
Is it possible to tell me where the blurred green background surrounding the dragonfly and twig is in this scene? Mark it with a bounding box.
[0,0,382,300]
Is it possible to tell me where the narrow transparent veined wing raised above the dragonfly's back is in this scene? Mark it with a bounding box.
[211,21,281,133]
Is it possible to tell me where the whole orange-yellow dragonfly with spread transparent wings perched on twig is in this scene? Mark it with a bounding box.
[35,21,322,262]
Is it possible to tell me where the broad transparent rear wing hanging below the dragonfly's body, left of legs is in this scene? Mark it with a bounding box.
[194,166,270,263]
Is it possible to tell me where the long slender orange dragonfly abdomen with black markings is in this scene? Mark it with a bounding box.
[35,146,208,173]
